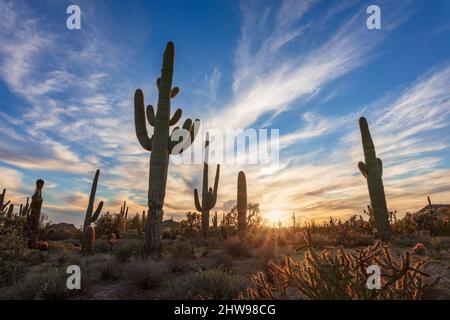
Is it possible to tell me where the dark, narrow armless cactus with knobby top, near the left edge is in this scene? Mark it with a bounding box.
[26,179,44,249]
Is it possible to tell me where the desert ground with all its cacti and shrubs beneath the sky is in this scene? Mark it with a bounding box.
[0,42,450,300]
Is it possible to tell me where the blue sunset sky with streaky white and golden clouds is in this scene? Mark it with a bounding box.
[0,0,450,226]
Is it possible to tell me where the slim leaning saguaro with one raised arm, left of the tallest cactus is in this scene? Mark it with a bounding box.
[81,170,103,253]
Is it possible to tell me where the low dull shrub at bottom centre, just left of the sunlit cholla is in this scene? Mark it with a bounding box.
[167,268,246,299]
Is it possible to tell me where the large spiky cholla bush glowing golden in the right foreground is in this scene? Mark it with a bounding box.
[247,235,438,300]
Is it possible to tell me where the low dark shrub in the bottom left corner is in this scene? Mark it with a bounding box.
[1,268,77,300]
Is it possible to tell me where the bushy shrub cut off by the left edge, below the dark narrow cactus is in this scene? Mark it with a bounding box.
[0,230,31,285]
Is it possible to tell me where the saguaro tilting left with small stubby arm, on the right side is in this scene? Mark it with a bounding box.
[358,117,390,241]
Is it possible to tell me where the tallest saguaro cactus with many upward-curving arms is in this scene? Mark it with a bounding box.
[134,42,200,257]
